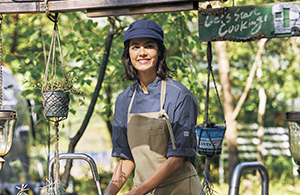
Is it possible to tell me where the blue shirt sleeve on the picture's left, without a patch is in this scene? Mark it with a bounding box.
[112,94,133,160]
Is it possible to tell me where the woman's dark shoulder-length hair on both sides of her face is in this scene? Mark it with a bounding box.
[121,39,174,81]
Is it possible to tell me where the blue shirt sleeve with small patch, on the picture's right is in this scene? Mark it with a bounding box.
[167,93,198,157]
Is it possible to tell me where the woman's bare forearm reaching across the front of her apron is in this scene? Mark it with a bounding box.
[123,156,184,195]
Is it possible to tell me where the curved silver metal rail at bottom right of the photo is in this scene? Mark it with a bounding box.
[228,162,269,195]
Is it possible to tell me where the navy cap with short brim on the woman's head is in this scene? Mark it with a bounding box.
[124,20,164,43]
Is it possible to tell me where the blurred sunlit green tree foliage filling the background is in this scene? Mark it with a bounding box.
[2,1,300,194]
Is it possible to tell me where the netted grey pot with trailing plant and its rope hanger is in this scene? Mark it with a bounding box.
[38,13,85,122]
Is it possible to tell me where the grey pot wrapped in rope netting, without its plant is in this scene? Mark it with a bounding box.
[42,90,70,118]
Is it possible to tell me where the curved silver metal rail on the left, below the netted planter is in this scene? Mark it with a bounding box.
[48,153,102,195]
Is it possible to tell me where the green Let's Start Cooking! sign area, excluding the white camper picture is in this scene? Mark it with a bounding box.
[198,4,284,41]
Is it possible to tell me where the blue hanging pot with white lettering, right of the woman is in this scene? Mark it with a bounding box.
[196,124,226,156]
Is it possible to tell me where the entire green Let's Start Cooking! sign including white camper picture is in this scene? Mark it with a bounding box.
[198,2,300,42]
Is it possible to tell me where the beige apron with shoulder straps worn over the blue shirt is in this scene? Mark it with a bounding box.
[127,80,202,195]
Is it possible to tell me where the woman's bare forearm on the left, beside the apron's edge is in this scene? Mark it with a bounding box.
[104,158,134,195]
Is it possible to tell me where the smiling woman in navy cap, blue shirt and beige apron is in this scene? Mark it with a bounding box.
[105,20,201,195]
